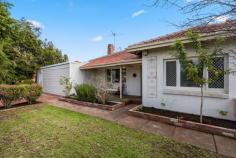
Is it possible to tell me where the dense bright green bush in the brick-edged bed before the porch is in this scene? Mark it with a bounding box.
[75,84,96,103]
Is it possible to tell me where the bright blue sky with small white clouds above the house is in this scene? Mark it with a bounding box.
[9,0,190,61]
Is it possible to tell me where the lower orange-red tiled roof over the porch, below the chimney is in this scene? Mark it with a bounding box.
[80,51,141,69]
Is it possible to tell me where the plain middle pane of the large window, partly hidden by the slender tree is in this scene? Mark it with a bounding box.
[180,58,199,87]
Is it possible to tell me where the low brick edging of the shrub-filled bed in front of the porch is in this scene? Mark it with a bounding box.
[58,97,127,111]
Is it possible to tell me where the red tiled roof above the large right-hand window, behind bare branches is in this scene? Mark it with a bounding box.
[127,21,236,52]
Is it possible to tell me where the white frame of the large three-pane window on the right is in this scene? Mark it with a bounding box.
[163,55,229,94]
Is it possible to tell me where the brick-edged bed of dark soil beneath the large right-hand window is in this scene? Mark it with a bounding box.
[129,106,236,139]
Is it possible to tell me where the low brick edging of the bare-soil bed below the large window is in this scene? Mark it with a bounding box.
[128,105,236,139]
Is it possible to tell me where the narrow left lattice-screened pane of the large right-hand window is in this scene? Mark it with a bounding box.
[166,61,176,86]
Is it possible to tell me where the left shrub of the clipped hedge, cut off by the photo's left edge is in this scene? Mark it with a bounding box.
[0,85,23,108]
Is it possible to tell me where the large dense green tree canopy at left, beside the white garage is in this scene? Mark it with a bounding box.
[0,0,68,84]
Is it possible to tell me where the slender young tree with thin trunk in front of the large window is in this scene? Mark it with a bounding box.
[173,30,226,123]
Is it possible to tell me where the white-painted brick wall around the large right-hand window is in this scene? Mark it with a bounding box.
[142,40,236,120]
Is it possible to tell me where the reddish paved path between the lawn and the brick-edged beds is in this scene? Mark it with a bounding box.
[40,94,236,158]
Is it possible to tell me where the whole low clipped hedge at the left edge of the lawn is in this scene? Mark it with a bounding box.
[0,84,42,108]
